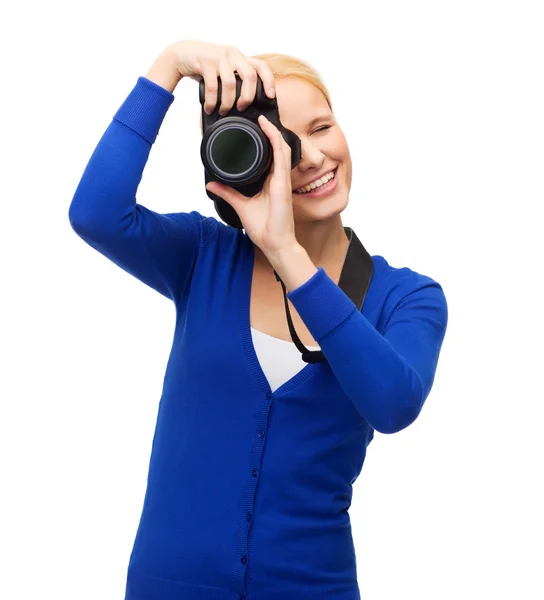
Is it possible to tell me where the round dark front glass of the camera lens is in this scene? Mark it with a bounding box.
[209,126,259,177]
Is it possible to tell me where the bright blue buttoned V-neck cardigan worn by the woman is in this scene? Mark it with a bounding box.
[69,77,448,600]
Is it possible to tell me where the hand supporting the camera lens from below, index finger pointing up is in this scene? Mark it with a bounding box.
[206,115,298,256]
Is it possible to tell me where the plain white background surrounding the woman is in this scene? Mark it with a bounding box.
[0,0,544,600]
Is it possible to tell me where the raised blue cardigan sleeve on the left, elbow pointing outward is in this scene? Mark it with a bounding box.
[69,77,203,300]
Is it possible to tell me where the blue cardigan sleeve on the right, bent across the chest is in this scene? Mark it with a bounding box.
[287,267,448,433]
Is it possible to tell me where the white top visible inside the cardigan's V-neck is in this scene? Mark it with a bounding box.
[251,327,321,392]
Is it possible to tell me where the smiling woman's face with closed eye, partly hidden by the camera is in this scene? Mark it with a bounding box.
[276,79,352,222]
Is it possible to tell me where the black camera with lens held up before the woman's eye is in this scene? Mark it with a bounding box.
[199,72,302,229]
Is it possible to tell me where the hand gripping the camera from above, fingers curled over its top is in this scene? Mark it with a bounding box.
[168,40,276,116]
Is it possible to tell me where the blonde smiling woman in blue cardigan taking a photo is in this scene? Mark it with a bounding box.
[69,40,447,600]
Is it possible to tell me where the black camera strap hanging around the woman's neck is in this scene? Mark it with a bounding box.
[274,227,374,363]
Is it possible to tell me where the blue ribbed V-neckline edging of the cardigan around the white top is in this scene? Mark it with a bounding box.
[238,235,320,396]
